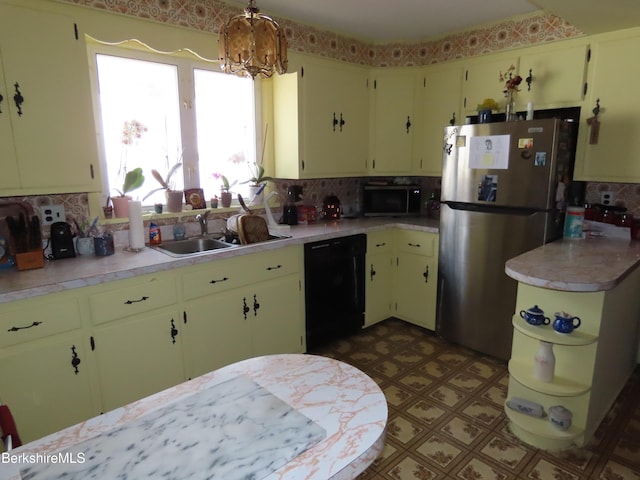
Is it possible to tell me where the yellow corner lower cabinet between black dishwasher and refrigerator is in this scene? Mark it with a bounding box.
[365,229,438,330]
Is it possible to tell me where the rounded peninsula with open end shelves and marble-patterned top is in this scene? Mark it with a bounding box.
[505,238,640,450]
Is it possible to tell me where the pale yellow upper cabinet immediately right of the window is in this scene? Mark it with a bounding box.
[272,55,369,178]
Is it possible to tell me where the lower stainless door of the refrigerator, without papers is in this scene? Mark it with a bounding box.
[436,204,549,360]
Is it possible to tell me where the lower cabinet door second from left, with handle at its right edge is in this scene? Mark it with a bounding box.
[93,310,185,411]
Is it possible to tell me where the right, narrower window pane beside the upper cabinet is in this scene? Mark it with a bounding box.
[194,69,256,201]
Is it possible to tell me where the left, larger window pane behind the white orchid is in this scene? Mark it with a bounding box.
[96,54,183,205]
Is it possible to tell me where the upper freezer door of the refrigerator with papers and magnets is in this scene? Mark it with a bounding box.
[441,119,570,210]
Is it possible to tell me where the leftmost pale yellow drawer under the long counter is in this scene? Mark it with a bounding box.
[0,297,82,348]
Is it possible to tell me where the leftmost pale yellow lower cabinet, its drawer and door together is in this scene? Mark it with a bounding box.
[0,294,96,442]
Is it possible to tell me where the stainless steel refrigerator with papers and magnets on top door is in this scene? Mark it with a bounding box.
[437,119,577,360]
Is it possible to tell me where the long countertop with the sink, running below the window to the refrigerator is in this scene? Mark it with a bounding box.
[0,217,438,303]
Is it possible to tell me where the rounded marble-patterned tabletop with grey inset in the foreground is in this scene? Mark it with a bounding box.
[5,354,388,480]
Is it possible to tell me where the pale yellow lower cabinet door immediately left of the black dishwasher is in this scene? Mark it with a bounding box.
[247,275,305,357]
